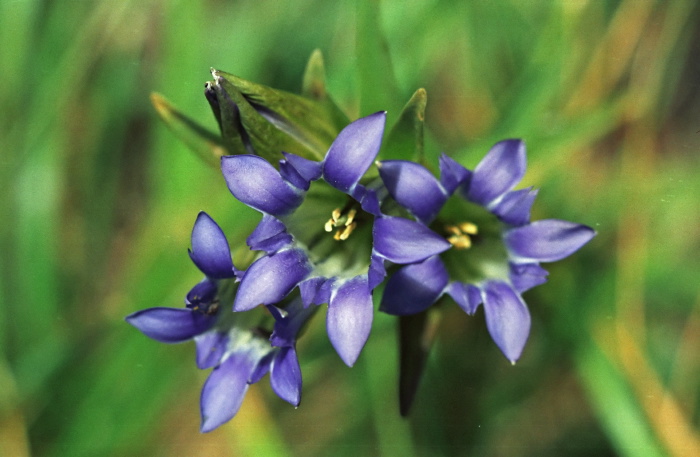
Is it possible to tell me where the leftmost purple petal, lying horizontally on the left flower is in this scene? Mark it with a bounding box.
[126,308,216,343]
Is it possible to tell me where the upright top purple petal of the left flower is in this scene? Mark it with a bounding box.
[189,211,234,279]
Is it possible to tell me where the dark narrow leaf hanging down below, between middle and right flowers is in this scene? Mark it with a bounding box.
[398,310,439,417]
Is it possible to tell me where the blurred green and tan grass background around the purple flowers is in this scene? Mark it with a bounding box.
[0,0,700,457]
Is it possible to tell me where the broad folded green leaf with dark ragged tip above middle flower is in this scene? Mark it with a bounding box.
[209,70,349,163]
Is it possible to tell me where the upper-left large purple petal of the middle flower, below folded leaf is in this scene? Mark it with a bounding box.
[221,155,304,216]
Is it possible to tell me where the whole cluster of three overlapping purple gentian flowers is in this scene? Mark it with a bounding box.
[126,68,595,432]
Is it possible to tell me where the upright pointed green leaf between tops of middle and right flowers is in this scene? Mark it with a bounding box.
[381,89,428,163]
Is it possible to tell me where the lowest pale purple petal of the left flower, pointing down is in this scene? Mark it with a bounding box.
[200,353,255,433]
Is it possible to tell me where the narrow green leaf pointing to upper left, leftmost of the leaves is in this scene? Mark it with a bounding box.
[151,92,230,167]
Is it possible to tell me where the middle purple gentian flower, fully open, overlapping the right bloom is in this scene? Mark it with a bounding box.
[221,112,450,366]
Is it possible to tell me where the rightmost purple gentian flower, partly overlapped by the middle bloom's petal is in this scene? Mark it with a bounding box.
[379,140,595,363]
